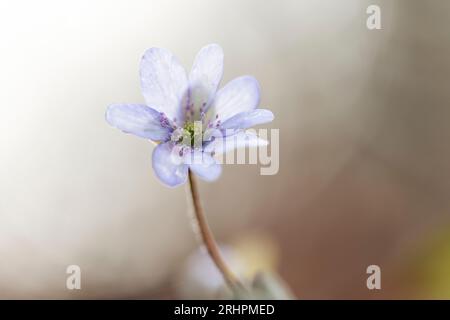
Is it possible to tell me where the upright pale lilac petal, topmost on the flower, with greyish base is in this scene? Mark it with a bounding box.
[189,44,223,111]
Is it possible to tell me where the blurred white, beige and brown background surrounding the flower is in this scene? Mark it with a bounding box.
[0,0,450,299]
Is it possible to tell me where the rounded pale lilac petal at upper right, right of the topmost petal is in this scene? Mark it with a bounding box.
[211,76,260,123]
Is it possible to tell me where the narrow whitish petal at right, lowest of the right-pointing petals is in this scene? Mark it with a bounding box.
[204,131,269,154]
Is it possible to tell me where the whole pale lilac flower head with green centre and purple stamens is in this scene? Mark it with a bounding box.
[106,44,274,187]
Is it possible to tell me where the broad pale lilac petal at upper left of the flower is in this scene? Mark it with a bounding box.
[140,48,188,122]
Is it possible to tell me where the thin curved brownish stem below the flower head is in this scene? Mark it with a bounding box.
[188,170,242,290]
